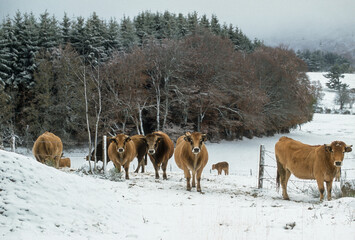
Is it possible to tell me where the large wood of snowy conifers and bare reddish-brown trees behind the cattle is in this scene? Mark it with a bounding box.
[0,12,315,144]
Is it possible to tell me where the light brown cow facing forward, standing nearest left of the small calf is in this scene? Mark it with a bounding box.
[174,132,208,192]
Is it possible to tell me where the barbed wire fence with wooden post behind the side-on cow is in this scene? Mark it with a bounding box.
[258,145,355,196]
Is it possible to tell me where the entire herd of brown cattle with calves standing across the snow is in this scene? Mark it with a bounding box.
[32,131,352,201]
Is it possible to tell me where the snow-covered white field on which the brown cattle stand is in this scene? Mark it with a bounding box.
[0,73,355,240]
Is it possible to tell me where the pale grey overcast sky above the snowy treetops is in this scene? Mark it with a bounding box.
[0,0,355,45]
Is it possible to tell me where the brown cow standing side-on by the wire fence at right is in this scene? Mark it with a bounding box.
[275,137,352,201]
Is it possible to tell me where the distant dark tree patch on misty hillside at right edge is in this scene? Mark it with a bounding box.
[297,50,354,73]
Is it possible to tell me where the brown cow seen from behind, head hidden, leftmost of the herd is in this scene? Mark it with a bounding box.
[32,132,63,168]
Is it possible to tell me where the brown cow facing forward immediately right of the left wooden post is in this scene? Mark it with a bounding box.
[108,134,137,179]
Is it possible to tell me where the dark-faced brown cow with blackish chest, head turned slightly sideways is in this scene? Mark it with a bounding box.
[143,131,174,179]
